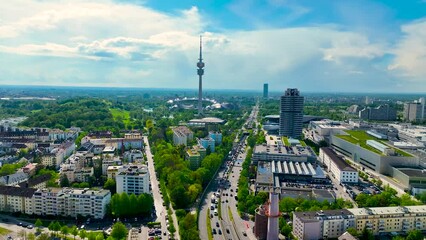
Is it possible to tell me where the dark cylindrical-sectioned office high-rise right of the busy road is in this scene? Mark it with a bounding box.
[279,88,304,138]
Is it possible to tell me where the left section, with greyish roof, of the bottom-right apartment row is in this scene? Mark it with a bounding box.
[293,209,356,240]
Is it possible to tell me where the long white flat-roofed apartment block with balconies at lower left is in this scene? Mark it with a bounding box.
[34,188,111,219]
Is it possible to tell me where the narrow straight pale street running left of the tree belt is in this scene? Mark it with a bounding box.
[142,136,175,239]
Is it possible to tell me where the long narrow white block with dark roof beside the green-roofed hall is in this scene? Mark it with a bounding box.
[319,147,359,183]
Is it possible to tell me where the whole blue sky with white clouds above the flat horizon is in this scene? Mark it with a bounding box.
[0,0,426,93]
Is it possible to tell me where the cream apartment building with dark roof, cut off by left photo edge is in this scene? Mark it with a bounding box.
[0,186,36,214]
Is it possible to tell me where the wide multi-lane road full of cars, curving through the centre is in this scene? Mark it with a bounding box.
[198,105,259,240]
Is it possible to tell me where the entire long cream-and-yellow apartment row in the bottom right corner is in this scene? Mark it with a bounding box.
[293,205,426,240]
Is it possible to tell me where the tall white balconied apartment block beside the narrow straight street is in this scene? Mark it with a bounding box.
[115,165,150,195]
